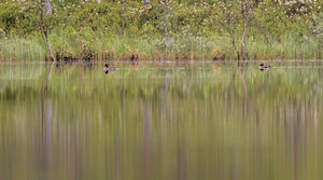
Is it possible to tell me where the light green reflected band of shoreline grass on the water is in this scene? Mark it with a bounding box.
[0,65,322,102]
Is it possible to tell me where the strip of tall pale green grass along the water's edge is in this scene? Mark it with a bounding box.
[0,31,322,61]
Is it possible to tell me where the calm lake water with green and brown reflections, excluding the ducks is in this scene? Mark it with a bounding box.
[0,62,323,180]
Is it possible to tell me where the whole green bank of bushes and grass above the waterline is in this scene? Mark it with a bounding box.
[0,0,322,60]
